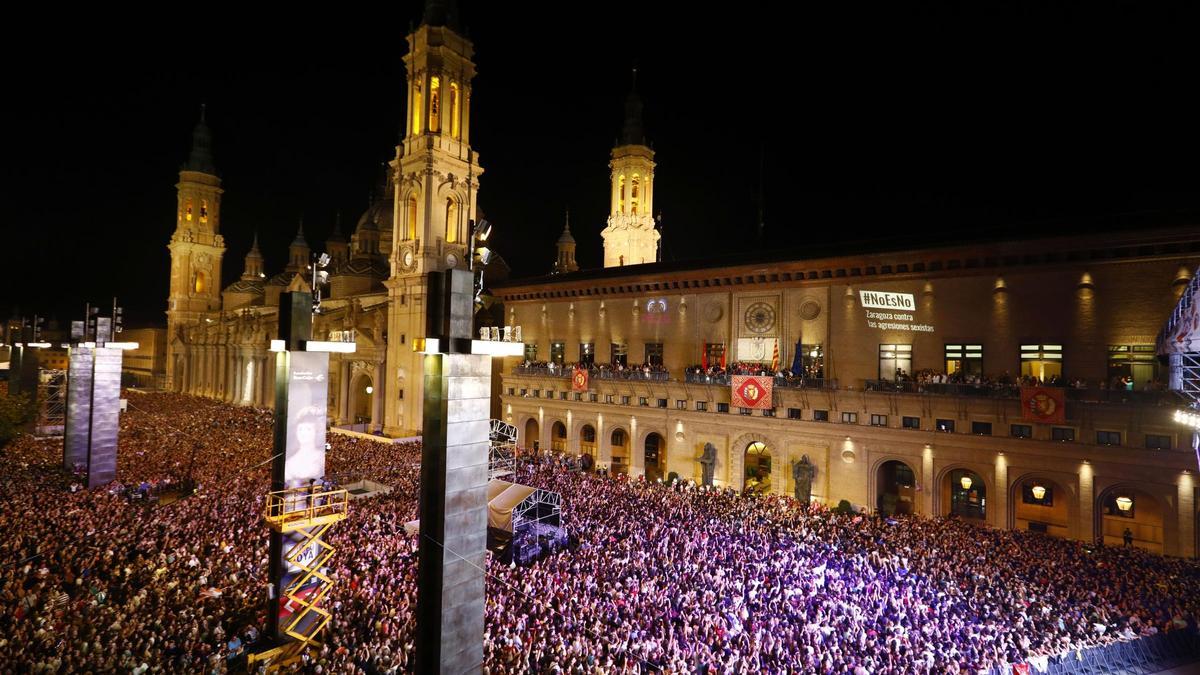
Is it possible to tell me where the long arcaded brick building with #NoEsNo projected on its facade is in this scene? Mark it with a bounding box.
[498,225,1200,556]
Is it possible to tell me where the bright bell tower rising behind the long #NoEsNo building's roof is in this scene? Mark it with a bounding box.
[600,68,659,267]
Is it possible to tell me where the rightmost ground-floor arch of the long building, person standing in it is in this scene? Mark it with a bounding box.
[1092,482,1176,554]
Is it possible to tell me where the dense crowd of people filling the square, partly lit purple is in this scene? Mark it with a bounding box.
[0,394,1200,675]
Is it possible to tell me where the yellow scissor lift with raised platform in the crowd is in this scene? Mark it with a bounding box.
[250,485,348,671]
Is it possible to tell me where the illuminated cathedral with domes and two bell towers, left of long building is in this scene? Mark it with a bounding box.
[167,5,482,436]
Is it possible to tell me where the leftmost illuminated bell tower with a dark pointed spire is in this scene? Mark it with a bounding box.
[167,106,224,389]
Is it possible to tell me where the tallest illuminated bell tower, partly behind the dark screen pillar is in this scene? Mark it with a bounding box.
[384,0,482,434]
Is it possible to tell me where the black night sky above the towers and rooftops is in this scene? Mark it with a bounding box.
[9,0,1200,324]
